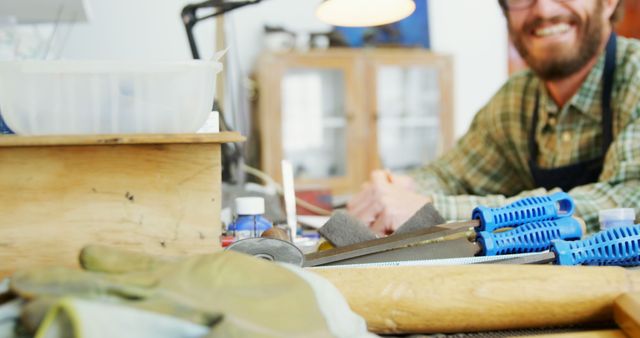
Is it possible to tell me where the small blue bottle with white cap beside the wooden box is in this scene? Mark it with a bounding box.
[227,197,273,240]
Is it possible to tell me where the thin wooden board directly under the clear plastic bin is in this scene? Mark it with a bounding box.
[0,132,245,147]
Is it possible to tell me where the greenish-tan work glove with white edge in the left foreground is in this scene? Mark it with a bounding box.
[11,246,373,338]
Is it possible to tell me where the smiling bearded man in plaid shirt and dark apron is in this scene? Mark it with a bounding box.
[347,0,640,234]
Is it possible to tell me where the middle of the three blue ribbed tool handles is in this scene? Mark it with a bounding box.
[476,217,582,256]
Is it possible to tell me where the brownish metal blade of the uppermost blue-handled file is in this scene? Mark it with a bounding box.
[304,220,479,267]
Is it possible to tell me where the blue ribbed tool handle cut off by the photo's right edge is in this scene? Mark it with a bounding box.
[551,225,640,266]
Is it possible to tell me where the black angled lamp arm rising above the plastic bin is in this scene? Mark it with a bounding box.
[181,0,262,59]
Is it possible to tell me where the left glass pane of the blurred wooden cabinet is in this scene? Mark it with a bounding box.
[280,68,347,179]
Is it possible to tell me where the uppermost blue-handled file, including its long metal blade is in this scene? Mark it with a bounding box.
[305,193,575,266]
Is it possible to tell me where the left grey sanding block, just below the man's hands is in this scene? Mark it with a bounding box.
[318,210,377,248]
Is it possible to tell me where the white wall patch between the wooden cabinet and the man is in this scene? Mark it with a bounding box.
[429,0,508,136]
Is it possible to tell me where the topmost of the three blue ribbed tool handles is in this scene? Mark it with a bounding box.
[471,192,575,232]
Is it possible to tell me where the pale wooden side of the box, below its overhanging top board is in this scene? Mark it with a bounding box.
[0,141,225,277]
